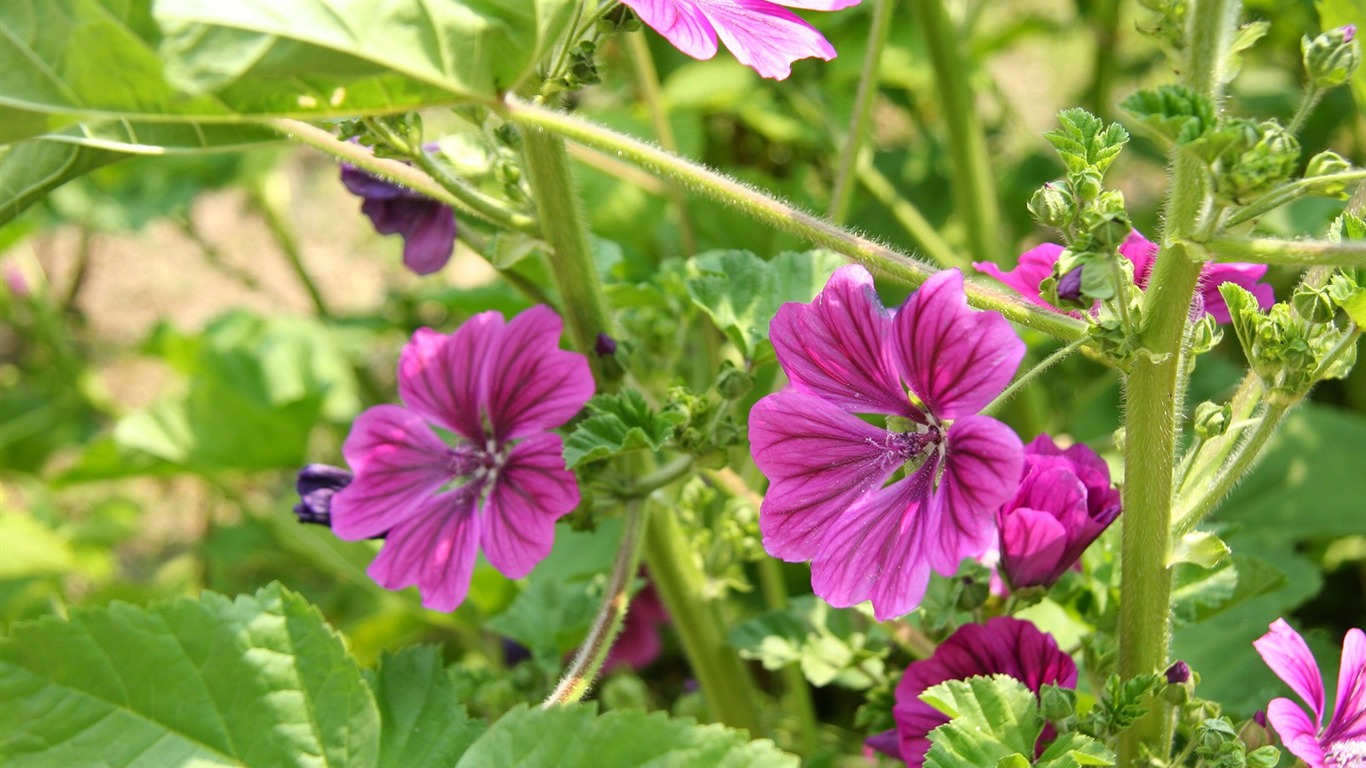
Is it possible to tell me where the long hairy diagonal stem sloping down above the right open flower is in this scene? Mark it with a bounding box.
[505,97,1086,342]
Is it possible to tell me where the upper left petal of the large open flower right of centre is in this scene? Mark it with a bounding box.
[769,265,910,415]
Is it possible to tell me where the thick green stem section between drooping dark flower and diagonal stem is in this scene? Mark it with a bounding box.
[522,127,622,388]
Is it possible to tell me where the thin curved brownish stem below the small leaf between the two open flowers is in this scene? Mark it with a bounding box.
[541,499,649,708]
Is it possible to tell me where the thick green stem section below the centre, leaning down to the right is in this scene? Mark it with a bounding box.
[645,506,762,735]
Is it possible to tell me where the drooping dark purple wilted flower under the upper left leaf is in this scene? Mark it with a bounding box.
[342,157,455,275]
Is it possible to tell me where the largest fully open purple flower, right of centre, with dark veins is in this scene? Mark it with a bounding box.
[750,266,1025,620]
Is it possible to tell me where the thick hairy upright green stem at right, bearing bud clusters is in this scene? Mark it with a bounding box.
[1119,0,1238,765]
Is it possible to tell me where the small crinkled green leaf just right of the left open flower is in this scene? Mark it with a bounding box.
[564,389,675,469]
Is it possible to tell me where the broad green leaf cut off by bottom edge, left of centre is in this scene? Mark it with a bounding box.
[456,704,799,768]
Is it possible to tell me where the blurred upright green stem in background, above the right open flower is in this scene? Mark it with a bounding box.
[911,0,1004,262]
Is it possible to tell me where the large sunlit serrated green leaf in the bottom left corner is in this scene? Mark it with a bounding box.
[0,585,380,768]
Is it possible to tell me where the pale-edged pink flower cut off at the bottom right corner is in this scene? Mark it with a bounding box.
[1253,619,1366,768]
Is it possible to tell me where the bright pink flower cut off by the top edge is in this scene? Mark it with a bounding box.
[622,0,859,81]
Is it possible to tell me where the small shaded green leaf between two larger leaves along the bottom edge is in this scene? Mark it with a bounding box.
[369,645,485,768]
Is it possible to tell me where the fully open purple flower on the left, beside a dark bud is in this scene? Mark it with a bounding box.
[332,306,593,611]
